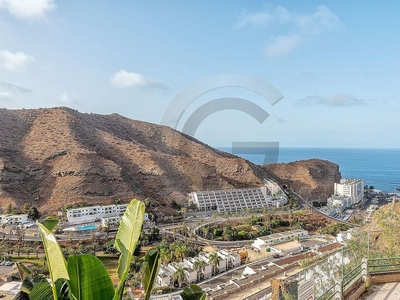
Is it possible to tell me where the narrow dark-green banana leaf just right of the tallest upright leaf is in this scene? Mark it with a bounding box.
[142,248,161,300]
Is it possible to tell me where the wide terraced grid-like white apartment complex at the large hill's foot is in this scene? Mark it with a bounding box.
[189,180,287,212]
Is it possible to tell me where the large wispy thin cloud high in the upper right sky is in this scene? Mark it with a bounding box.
[234,6,343,56]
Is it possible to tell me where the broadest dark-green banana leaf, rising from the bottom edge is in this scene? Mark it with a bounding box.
[67,254,114,300]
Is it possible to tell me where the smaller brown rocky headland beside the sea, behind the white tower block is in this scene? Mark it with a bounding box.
[263,159,341,200]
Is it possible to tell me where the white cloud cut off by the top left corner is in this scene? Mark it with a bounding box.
[0,0,56,20]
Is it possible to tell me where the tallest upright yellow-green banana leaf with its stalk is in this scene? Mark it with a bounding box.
[113,200,145,300]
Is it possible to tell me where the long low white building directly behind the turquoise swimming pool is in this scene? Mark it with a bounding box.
[67,204,128,224]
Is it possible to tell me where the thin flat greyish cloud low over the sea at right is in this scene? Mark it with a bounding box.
[298,93,366,107]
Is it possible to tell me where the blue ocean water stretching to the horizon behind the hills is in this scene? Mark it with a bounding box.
[220,147,400,193]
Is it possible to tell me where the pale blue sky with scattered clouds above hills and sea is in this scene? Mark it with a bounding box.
[0,0,400,148]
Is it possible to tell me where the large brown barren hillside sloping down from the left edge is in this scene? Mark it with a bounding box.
[0,108,337,213]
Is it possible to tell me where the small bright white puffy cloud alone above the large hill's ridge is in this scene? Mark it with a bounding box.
[110,70,164,87]
